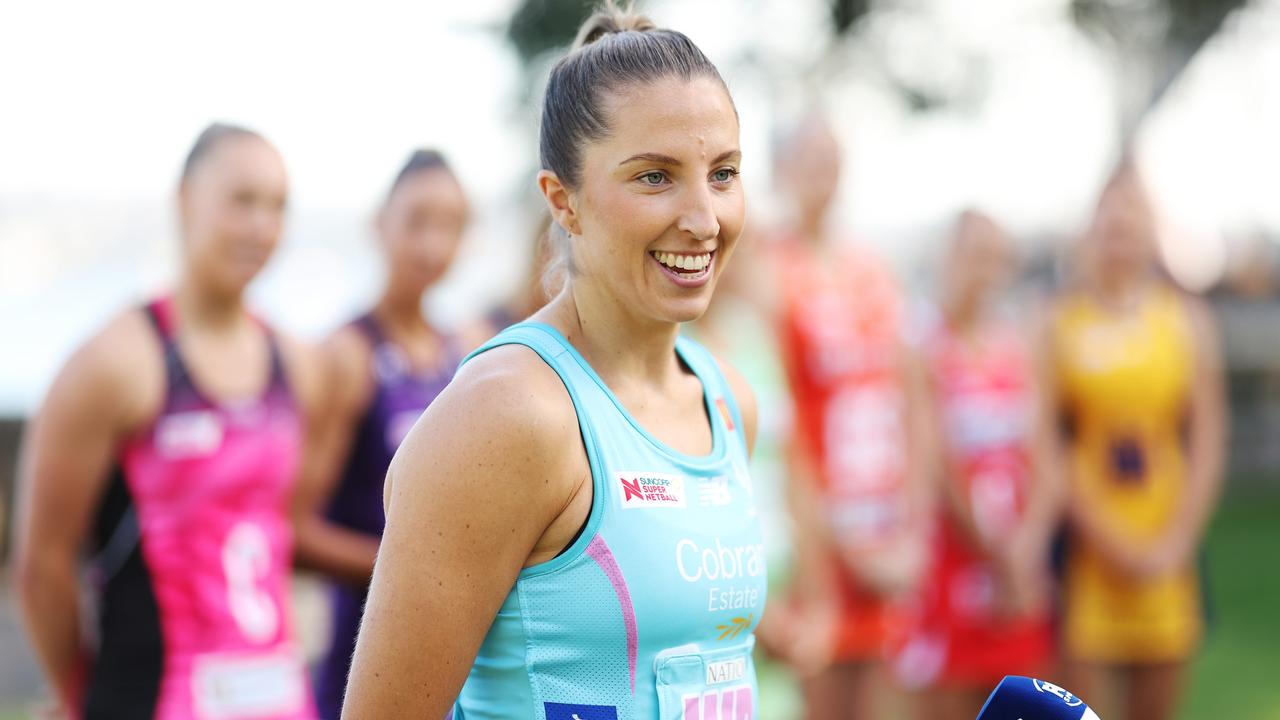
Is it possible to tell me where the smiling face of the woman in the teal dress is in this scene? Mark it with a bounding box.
[568,78,744,323]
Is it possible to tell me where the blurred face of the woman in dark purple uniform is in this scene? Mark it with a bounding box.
[378,168,467,292]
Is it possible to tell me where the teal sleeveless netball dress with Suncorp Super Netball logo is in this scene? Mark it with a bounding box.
[453,323,765,720]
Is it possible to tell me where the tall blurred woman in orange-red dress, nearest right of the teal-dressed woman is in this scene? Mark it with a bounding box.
[769,111,927,720]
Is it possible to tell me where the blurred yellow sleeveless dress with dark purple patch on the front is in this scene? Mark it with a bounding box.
[1053,287,1203,662]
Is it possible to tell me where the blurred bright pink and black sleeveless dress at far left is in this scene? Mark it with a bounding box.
[84,300,315,720]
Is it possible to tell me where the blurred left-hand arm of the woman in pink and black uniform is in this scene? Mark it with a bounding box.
[15,314,159,708]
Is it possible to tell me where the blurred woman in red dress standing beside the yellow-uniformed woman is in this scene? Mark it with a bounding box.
[897,210,1060,720]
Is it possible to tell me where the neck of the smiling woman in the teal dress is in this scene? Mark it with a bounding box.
[540,279,680,386]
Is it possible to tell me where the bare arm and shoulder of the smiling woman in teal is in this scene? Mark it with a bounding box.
[343,347,581,719]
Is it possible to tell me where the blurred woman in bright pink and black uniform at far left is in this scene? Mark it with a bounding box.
[18,124,319,720]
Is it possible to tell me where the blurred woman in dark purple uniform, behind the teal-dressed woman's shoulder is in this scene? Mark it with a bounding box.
[285,150,471,719]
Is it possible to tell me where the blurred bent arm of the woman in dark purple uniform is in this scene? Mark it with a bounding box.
[291,328,379,587]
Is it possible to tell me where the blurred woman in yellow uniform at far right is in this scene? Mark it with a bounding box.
[1047,164,1226,720]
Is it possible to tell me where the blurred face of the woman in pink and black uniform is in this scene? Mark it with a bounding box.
[179,136,288,295]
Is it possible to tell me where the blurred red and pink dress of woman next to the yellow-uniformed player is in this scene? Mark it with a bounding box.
[902,313,1052,688]
